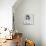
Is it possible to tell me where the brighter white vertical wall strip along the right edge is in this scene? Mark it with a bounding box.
[41,0,46,46]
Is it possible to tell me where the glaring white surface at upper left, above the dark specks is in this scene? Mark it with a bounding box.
[0,0,16,29]
